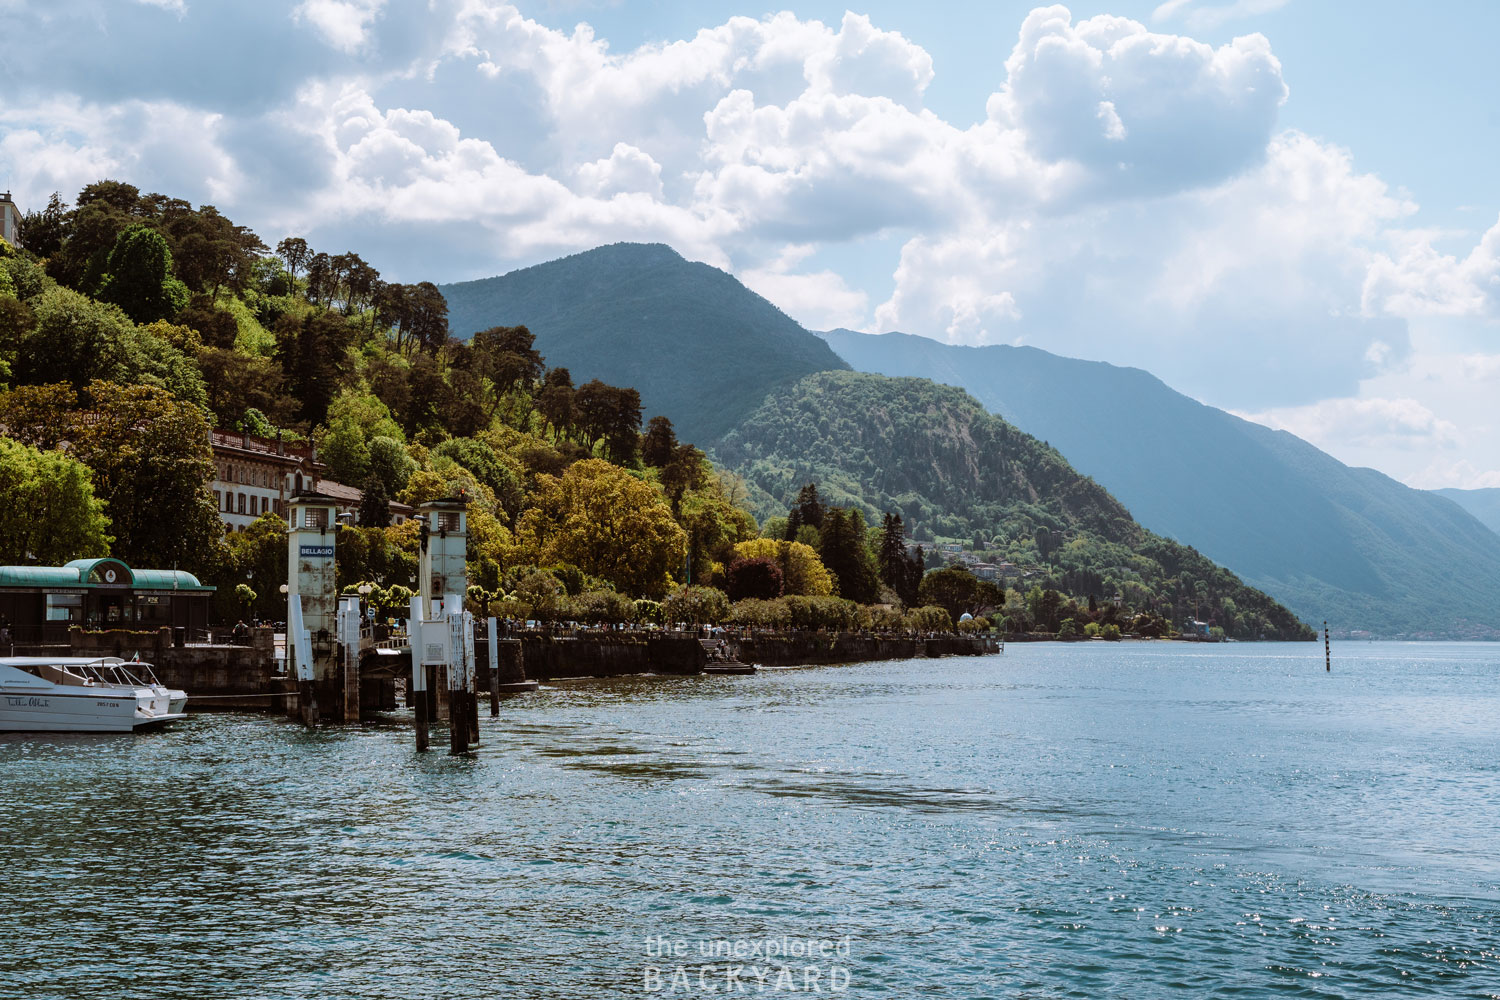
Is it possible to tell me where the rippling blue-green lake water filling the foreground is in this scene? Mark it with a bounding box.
[0,643,1500,999]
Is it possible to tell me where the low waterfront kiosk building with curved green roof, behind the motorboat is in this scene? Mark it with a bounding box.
[0,559,215,643]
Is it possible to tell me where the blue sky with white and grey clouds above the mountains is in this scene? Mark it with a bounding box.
[0,0,1500,487]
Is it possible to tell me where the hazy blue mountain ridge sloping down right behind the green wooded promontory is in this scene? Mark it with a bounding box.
[821,330,1500,639]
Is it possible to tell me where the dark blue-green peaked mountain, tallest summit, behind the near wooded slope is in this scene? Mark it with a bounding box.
[441,243,848,442]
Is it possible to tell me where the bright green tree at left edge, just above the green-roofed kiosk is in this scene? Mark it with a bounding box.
[0,438,110,565]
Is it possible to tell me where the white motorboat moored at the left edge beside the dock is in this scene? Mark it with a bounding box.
[0,657,188,733]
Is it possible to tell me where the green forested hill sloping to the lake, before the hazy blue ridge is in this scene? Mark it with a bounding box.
[716,372,1307,639]
